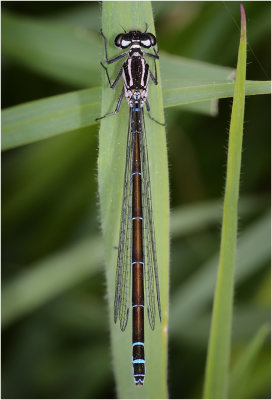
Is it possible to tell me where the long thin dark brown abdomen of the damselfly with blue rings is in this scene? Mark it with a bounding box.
[131,108,145,385]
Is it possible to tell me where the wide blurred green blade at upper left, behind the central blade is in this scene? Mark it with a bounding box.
[2,12,100,87]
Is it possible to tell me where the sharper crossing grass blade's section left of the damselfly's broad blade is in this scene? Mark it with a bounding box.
[2,88,101,150]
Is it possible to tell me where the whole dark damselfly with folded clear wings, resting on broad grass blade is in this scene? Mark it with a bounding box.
[97,28,164,385]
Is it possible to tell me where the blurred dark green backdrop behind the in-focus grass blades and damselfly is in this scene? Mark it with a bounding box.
[2,2,271,398]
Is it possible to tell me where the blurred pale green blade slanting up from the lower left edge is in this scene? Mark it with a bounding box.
[2,238,103,326]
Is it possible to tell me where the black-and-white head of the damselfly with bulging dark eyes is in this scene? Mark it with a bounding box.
[114,31,157,49]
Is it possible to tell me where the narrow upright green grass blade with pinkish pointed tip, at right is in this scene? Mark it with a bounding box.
[204,6,246,399]
